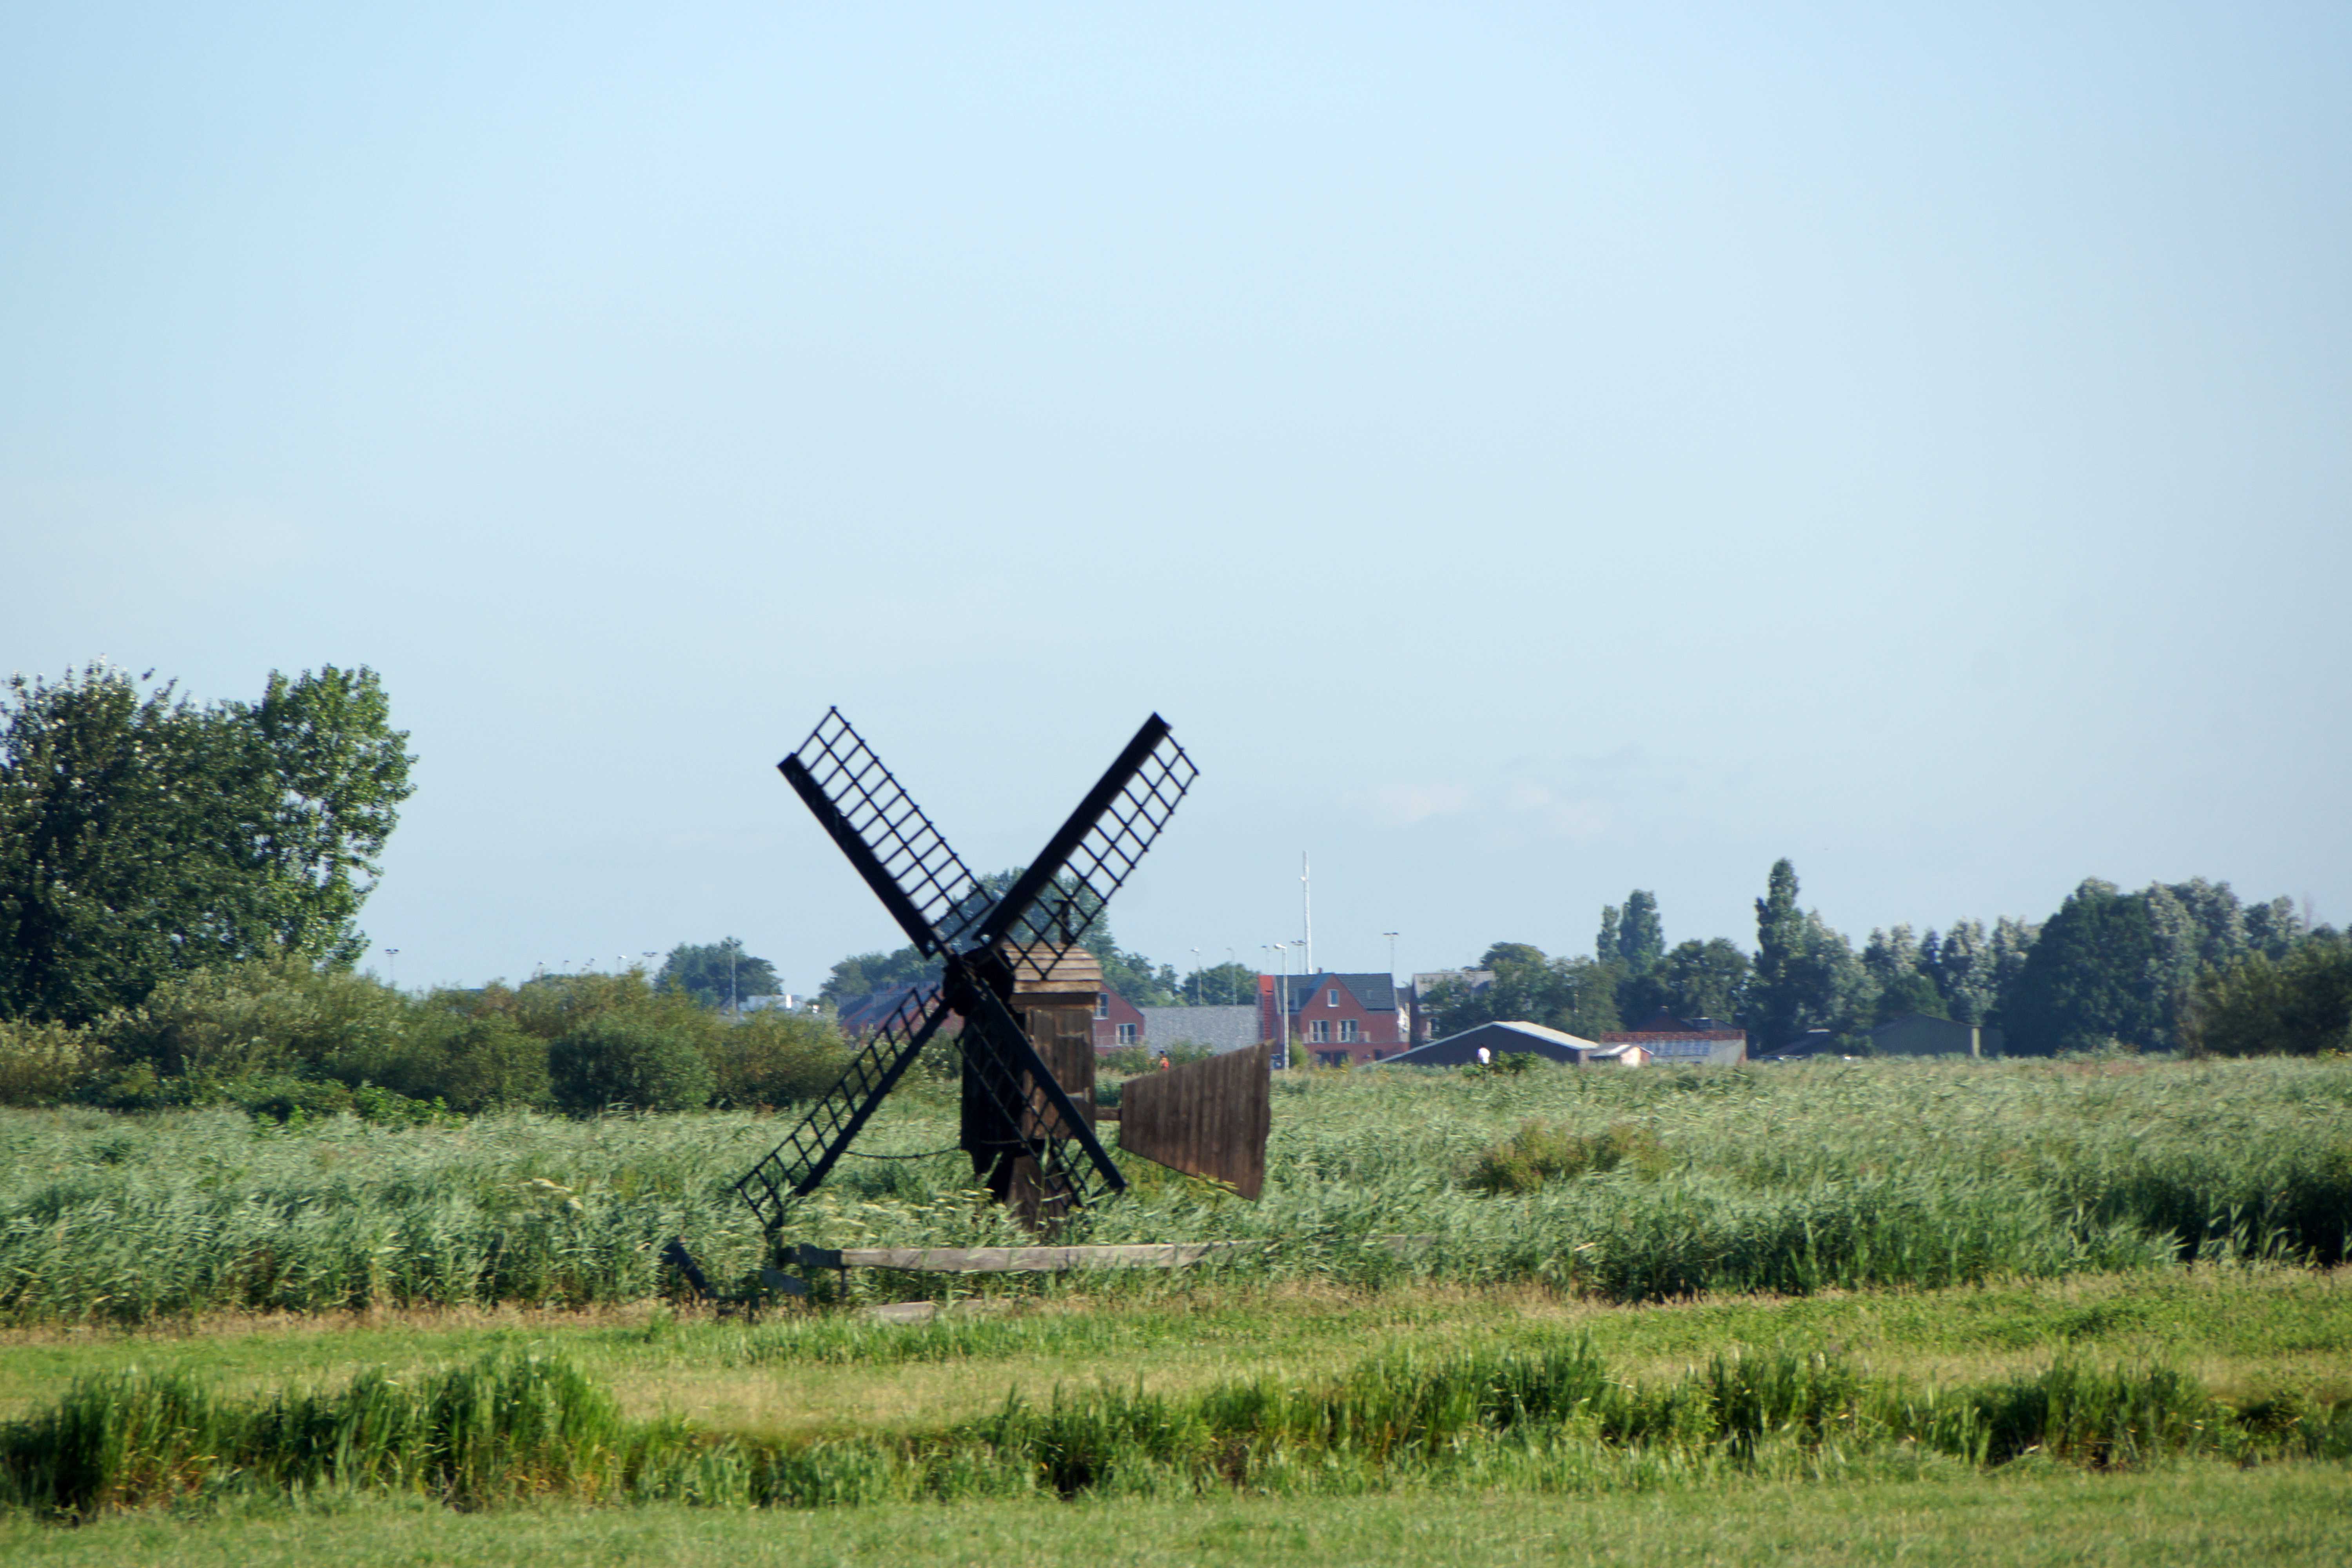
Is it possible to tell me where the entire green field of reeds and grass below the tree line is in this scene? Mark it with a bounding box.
[0,1060,2352,1563]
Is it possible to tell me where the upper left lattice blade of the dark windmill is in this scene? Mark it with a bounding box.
[776,708,988,957]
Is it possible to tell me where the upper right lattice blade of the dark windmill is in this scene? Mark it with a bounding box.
[971,712,1200,966]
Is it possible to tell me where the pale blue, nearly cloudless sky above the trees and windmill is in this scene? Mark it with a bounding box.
[0,5,2352,990]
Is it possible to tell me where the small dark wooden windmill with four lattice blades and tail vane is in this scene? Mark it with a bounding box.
[736,708,1265,1239]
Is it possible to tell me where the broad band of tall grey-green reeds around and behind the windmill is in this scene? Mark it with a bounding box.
[0,1060,2352,1323]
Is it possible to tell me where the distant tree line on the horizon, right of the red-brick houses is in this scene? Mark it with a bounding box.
[1428,860,2352,1056]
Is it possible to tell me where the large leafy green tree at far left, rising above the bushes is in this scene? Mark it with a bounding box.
[0,665,414,1023]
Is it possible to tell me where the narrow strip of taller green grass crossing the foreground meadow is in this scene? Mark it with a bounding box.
[0,1340,2352,1519]
